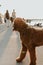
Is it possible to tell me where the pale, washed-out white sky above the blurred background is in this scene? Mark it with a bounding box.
[0,0,43,19]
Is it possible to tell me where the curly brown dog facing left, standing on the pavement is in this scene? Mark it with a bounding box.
[13,18,43,65]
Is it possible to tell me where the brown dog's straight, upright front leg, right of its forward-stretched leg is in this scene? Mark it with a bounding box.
[29,47,36,65]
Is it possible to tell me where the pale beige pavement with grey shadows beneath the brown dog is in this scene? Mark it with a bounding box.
[0,27,43,65]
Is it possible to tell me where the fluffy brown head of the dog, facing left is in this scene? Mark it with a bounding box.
[13,18,27,31]
